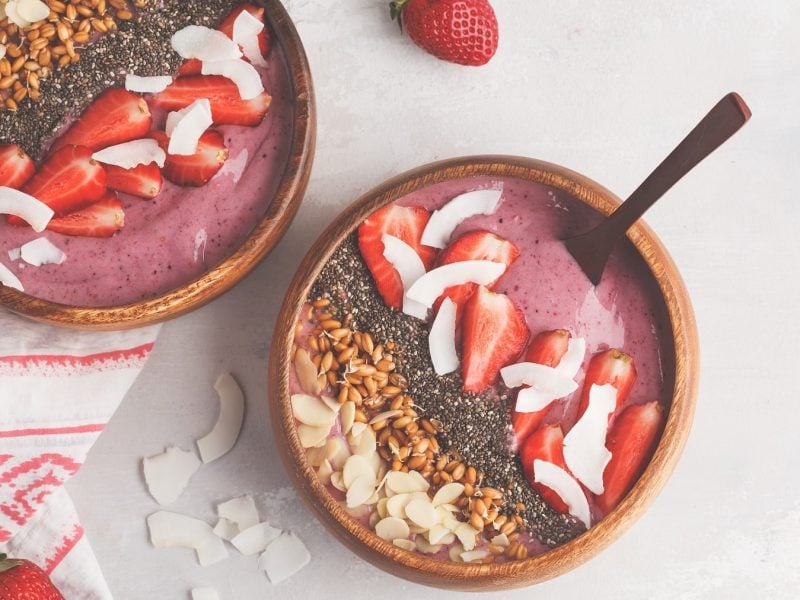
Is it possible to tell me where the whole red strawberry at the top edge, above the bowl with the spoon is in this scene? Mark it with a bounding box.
[389,0,498,67]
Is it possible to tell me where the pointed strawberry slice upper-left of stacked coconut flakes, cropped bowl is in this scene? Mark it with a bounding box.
[51,88,153,152]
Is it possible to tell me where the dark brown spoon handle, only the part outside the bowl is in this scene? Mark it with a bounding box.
[601,92,751,237]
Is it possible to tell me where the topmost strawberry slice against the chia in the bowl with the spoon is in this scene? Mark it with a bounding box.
[358,204,436,310]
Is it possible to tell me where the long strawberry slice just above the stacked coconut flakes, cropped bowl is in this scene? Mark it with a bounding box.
[152,75,272,127]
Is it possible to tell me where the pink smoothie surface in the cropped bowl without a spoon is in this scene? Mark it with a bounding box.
[0,45,293,306]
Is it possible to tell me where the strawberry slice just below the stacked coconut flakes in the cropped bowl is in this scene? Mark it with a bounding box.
[150,129,228,187]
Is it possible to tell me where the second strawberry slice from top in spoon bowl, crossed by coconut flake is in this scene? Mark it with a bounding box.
[434,230,519,323]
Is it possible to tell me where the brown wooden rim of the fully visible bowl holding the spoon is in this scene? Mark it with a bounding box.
[269,156,698,591]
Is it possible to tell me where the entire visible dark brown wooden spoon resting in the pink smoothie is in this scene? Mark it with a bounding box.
[564,92,751,285]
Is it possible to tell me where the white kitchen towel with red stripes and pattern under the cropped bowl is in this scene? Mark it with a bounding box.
[0,309,159,600]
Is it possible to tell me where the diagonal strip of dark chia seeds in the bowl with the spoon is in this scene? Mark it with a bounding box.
[309,234,584,547]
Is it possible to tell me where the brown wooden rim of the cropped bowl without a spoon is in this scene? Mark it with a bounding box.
[0,0,316,330]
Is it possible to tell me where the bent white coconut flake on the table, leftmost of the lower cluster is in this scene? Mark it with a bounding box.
[147,510,228,567]
